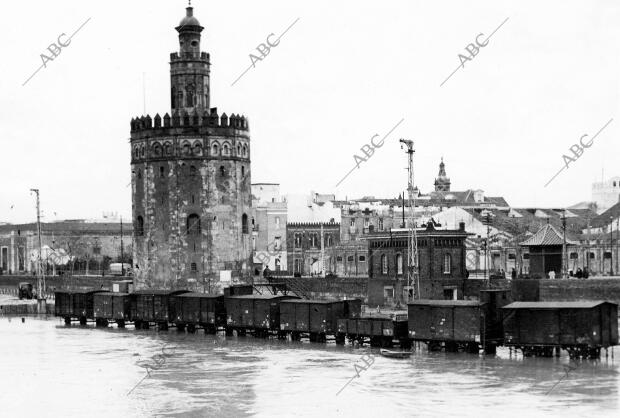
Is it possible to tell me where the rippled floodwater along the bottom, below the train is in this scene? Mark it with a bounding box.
[0,318,620,417]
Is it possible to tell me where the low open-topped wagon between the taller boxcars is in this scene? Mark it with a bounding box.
[336,315,411,348]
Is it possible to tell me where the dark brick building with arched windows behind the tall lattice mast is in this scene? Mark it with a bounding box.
[367,222,468,306]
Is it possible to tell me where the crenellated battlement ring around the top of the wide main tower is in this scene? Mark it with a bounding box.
[130,108,250,139]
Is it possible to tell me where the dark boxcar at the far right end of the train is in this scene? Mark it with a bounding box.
[503,301,618,358]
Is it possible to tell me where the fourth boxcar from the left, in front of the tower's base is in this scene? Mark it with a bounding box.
[171,292,226,334]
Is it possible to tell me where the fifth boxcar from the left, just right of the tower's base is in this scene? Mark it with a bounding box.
[224,295,296,337]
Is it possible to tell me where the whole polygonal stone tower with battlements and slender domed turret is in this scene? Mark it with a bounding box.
[130,7,252,292]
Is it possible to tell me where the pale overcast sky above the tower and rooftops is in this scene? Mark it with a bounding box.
[0,0,620,222]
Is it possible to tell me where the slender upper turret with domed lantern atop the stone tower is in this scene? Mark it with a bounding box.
[170,6,211,115]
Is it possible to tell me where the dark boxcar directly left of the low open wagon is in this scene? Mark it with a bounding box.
[280,299,362,342]
